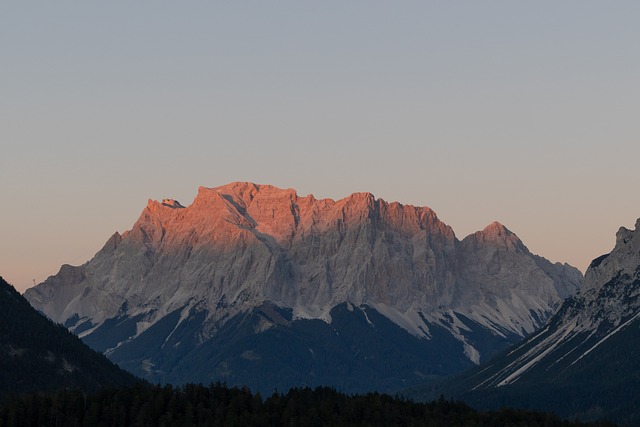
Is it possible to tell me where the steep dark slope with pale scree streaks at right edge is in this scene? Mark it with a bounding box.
[418,219,640,425]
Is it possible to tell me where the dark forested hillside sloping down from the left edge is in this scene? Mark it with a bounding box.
[0,277,137,400]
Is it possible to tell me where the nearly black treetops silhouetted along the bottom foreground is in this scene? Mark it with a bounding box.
[0,383,611,427]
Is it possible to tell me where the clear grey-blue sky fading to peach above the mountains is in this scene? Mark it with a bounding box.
[0,0,640,291]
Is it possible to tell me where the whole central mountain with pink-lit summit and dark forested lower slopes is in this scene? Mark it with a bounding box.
[25,183,582,392]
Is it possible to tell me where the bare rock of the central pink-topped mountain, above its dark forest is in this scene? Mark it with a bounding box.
[25,183,582,392]
